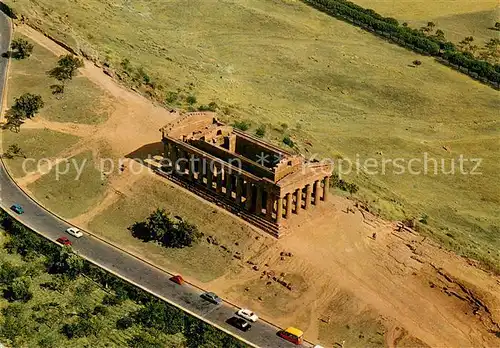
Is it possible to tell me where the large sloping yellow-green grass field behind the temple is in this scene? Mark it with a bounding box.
[6,0,500,269]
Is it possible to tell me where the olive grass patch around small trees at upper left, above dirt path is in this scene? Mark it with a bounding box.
[7,35,107,124]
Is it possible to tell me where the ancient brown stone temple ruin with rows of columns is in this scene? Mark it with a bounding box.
[160,112,332,237]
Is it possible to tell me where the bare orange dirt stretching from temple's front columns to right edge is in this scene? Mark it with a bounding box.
[210,197,500,347]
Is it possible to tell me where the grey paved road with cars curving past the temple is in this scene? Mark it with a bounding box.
[0,9,312,347]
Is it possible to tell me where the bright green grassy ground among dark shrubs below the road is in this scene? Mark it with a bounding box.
[0,230,184,348]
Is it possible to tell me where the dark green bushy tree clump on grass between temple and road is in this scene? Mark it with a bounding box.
[129,208,202,248]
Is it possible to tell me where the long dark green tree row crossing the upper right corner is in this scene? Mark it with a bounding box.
[304,0,500,86]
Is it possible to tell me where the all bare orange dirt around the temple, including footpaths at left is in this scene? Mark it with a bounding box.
[6,23,500,347]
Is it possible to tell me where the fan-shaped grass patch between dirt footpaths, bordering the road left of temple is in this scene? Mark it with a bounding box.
[28,151,107,218]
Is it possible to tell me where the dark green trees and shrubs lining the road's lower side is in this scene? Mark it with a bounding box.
[0,211,244,348]
